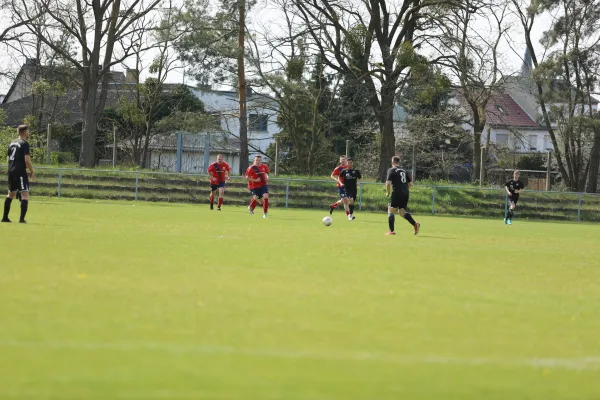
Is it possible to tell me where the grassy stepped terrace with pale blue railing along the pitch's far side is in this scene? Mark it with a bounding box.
[5,166,600,222]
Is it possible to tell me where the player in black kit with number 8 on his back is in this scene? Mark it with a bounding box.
[385,157,421,235]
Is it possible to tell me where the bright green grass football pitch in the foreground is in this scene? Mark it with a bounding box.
[0,197,600,400]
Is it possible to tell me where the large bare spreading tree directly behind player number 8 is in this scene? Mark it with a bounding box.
[294,0,474,180]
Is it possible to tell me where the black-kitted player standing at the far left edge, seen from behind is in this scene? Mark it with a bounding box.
[2,125,35,224]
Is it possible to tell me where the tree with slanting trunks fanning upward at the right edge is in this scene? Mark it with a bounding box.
[511,0,600,191]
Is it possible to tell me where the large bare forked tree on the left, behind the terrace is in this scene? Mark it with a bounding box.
[12,0,162,167]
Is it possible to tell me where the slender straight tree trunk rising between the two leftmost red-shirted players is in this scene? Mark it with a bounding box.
[237,0,250,175]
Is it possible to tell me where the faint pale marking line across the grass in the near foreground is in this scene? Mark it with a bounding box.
[0,341,600,371]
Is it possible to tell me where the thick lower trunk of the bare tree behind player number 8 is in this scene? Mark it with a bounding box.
[377,88,396,182]
